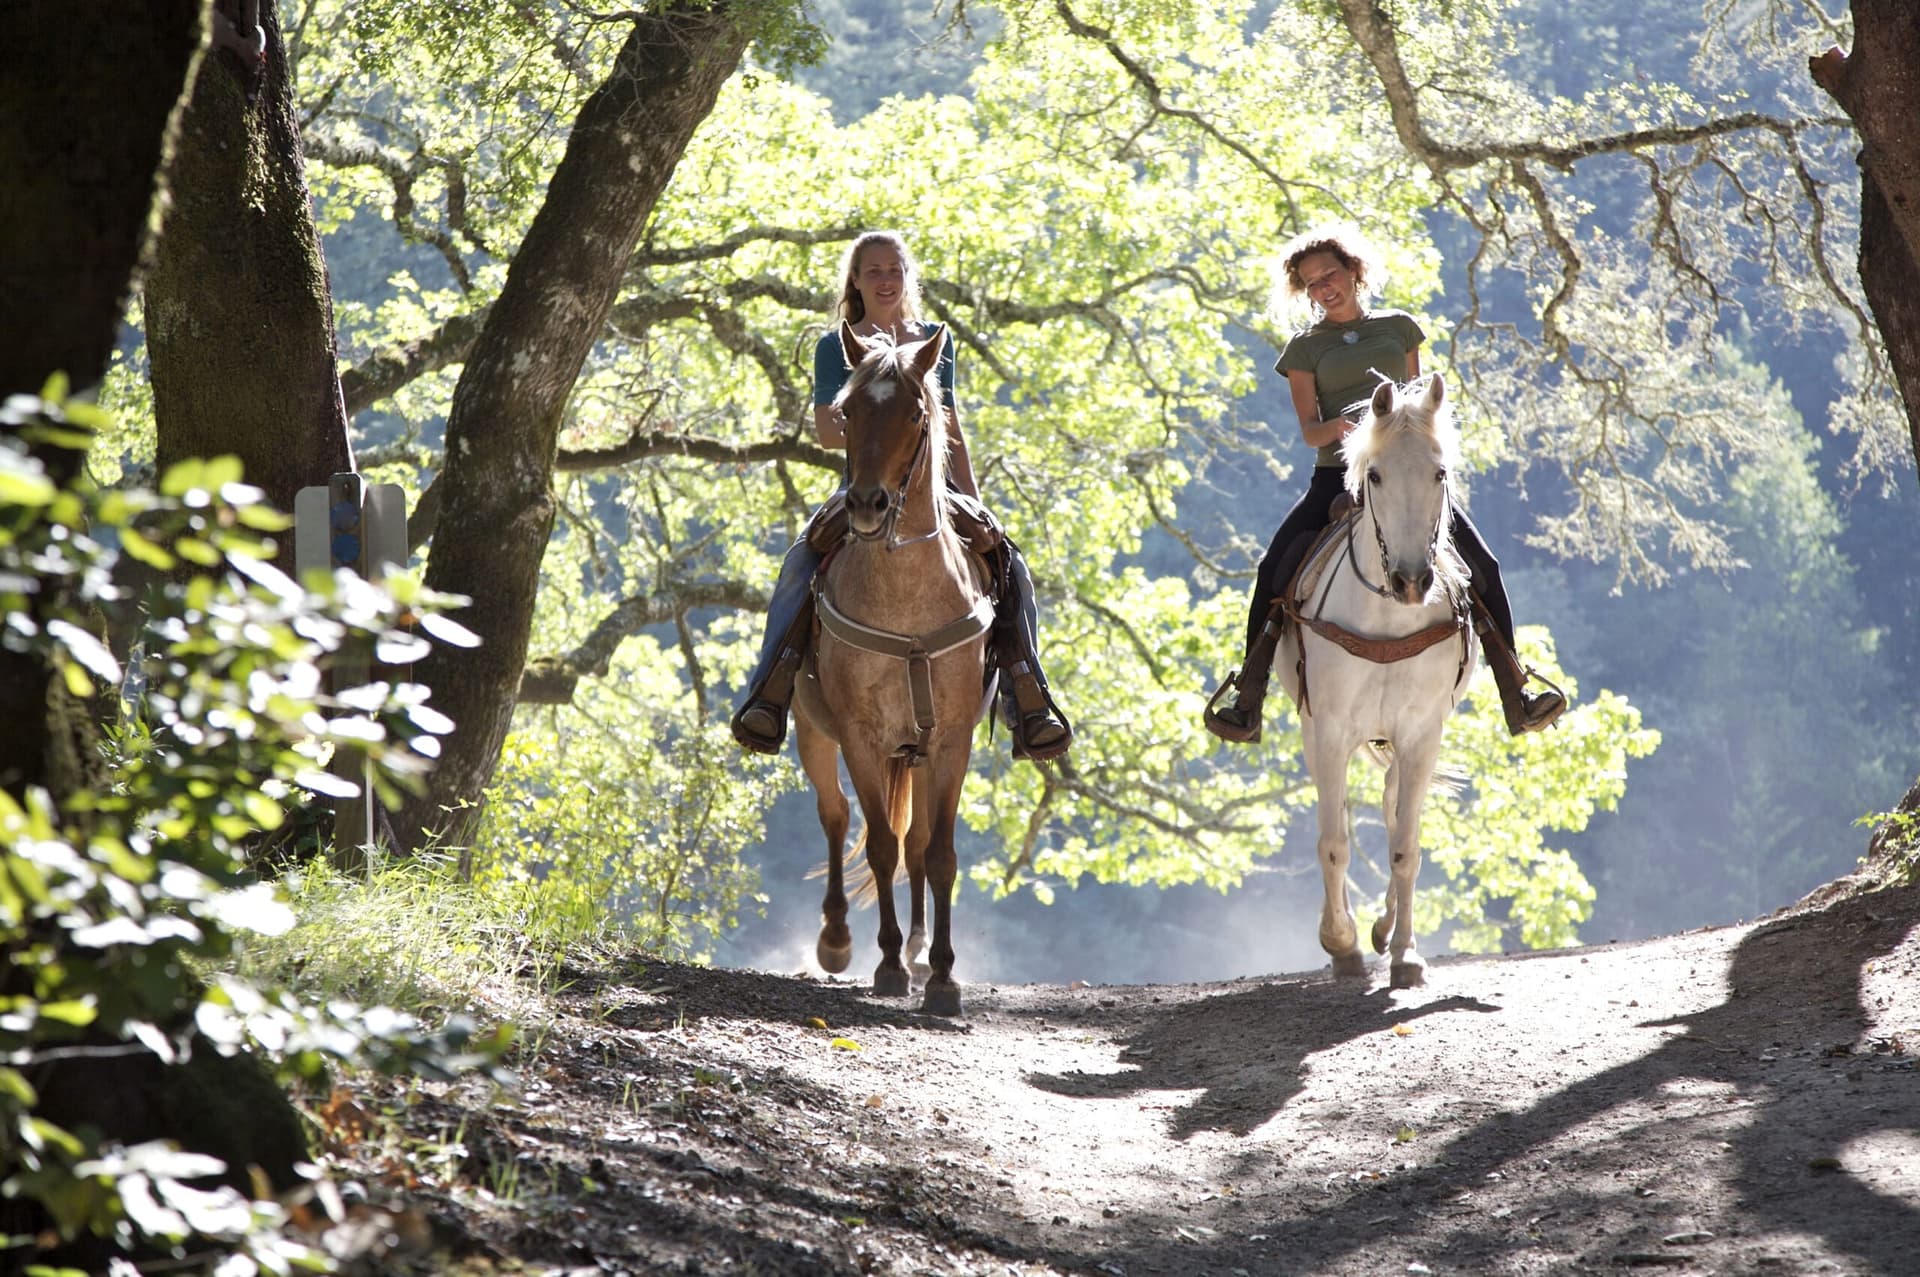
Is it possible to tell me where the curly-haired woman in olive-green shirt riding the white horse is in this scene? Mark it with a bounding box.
[1206,225,1567,741]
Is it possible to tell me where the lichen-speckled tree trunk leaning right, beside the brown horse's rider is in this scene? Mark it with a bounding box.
[394,2,747,845]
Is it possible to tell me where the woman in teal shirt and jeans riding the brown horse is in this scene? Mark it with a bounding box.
[732,230,1073,760]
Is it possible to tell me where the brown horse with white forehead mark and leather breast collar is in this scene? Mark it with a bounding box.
[795,321,993,1016]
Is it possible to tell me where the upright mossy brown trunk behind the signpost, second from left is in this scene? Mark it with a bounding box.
[144,0,353,526]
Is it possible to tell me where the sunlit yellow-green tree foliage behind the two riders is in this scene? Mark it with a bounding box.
[263,4,1658,937]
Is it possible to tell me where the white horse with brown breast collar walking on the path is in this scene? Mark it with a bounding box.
[1277,376,1478,989]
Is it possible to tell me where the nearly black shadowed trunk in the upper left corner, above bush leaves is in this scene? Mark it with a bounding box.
[0,0,202,394]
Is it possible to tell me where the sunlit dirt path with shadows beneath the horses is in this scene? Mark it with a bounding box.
[334,875,1920,1277]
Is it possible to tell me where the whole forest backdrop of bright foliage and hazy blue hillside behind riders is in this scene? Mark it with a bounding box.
[90,0,1920,981]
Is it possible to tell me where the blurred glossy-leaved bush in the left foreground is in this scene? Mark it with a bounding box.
[0,386,505,1267]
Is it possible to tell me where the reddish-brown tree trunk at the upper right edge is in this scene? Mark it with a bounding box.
[1811,0,1920,461]
